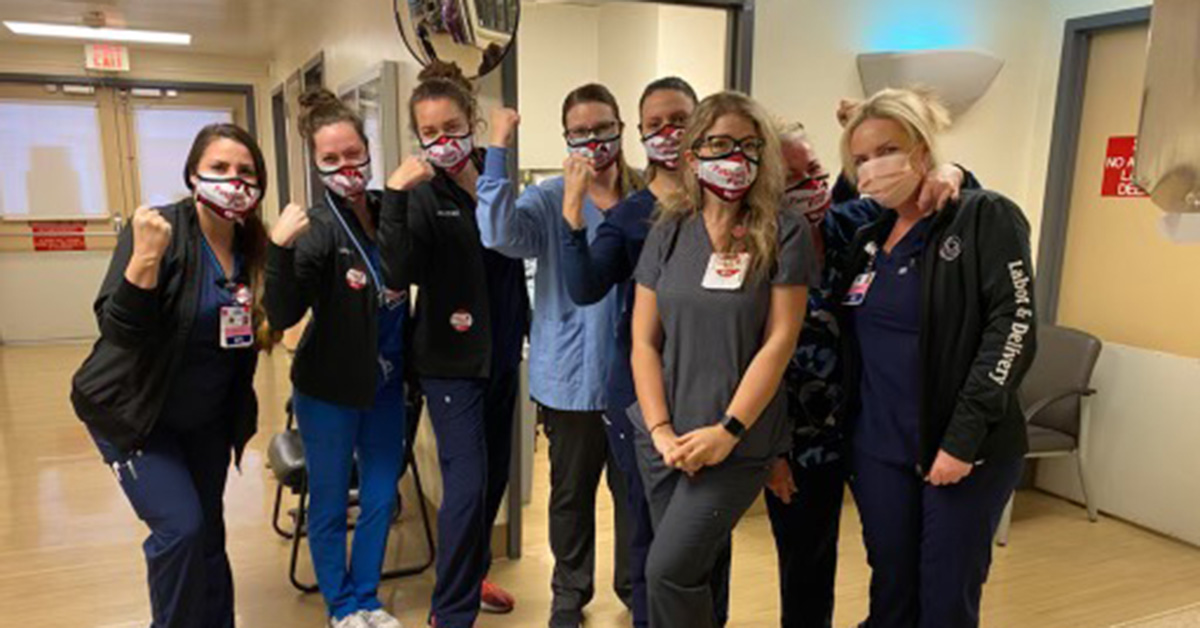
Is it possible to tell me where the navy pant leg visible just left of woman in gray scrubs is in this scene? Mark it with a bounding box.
[604,408,654,628]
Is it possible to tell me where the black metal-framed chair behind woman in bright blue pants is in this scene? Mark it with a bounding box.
[266,391,437,593]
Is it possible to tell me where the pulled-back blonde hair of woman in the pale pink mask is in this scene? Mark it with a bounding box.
[841,89,950,184]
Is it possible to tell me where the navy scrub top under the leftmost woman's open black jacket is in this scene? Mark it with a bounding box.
[162,235,244,431]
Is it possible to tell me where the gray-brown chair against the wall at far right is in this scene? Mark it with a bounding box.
[996,324,1103,545]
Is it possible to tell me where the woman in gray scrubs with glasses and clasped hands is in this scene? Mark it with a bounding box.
[631,92,817,628]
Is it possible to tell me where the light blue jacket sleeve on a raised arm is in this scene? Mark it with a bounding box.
[475,146,557,258]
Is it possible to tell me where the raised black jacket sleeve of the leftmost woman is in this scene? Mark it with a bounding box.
[92,220,175,348]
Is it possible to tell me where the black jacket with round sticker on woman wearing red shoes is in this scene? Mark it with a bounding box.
[379,159,529,378]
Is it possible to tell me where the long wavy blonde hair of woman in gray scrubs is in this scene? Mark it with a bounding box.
[659,91,785,273]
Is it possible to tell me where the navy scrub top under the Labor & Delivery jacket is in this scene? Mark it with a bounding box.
[852,217,932,466]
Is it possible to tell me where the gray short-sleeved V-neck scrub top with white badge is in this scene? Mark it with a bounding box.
[634,214,820,459]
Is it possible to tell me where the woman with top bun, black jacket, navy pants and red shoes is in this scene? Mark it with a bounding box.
[379,61,529,628]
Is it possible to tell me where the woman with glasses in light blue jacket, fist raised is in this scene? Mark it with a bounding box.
[478,84,641,628]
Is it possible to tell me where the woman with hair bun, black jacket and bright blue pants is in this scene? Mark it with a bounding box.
[266,89,408,628]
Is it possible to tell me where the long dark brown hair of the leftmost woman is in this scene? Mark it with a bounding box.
[184,122,282,352]
